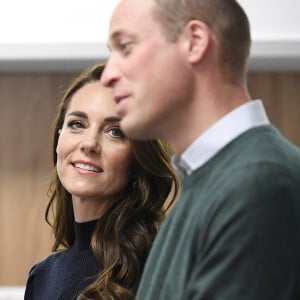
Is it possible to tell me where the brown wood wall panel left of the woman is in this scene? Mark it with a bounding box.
[0,74,72,285]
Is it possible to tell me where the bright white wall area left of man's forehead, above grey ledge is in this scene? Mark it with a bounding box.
[0,0,119,44]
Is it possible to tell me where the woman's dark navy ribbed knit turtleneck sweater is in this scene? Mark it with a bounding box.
[24,221,99,300]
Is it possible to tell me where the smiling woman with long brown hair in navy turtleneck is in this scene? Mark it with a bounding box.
[25,65,178,300]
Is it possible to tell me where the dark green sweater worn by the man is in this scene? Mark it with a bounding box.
[136,126,300,300]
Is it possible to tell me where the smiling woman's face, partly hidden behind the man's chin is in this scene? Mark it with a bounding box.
[56,82,132,204]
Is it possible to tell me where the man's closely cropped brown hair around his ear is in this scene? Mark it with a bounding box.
[153,0,251,76]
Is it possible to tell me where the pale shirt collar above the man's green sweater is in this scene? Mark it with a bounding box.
[172,99,270,177]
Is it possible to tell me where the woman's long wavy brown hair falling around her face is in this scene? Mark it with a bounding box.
[45,65,179,300]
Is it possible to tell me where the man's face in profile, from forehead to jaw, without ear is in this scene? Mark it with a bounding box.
[101,0,188,139]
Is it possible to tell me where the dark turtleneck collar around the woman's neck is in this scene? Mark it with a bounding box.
[72,220,98,251]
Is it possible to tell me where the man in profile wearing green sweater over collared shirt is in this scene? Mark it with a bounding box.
[102,0,300,300]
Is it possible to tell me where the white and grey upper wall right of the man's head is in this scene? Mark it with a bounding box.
[238,0,300,71]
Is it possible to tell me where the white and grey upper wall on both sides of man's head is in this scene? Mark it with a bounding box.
[0,0,300,72]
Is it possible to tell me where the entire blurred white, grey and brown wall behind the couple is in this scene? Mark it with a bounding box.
[0,0,300,299]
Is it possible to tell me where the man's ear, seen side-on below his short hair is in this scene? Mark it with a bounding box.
[184,20,211,64]
